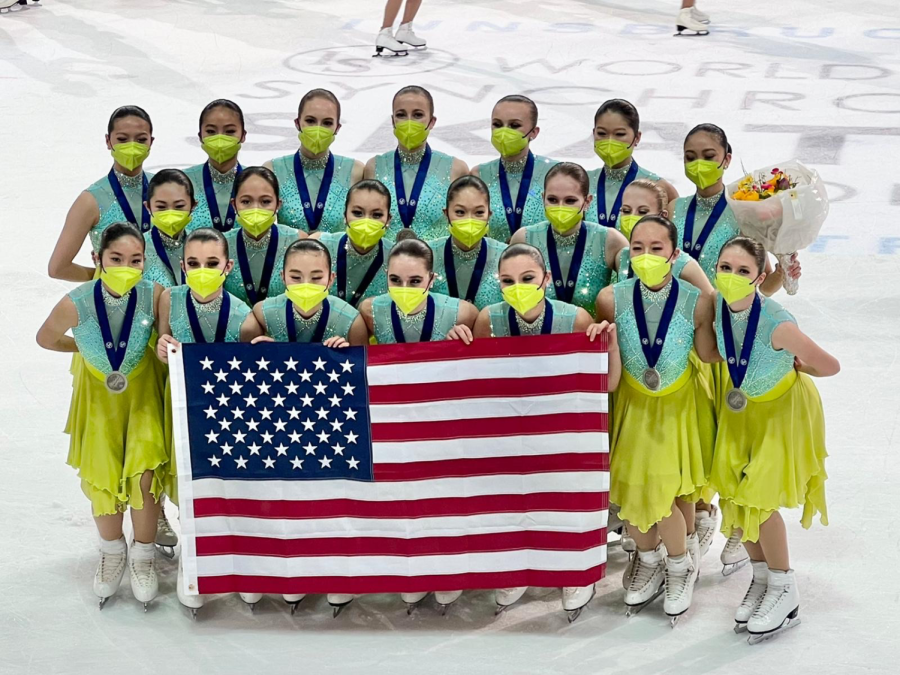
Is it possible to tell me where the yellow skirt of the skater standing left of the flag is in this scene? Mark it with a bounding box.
[66,350,168,516]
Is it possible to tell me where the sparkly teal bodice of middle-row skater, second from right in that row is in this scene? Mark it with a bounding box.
[525,221,612,316]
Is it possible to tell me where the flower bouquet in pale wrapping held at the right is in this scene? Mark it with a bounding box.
[725,160,828,295]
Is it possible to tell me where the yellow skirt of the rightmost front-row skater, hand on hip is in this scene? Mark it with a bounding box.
[710,372,828,541]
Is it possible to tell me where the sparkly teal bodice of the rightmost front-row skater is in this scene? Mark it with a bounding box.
[716,295,797,396]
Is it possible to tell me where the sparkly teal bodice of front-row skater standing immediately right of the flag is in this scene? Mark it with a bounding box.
[613,279,700,389]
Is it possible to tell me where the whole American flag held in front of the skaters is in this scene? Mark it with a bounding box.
[170,335,609,594]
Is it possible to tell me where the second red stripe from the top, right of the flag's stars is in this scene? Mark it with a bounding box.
[369,373,607,404]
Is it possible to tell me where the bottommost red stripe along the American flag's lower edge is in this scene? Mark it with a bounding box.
[198,563,606,602]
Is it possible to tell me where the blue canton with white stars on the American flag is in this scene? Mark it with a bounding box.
[183,343,373,481]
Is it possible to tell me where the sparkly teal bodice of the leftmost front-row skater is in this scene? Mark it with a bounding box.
[69,279,155,375]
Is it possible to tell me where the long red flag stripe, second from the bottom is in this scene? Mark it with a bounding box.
[197,528,606,558]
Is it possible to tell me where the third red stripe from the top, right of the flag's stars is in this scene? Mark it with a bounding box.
[372,413,608,443]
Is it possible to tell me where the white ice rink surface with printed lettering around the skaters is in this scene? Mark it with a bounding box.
[0,0,900,675]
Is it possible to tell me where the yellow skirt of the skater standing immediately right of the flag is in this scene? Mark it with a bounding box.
[609,366,716,532]
